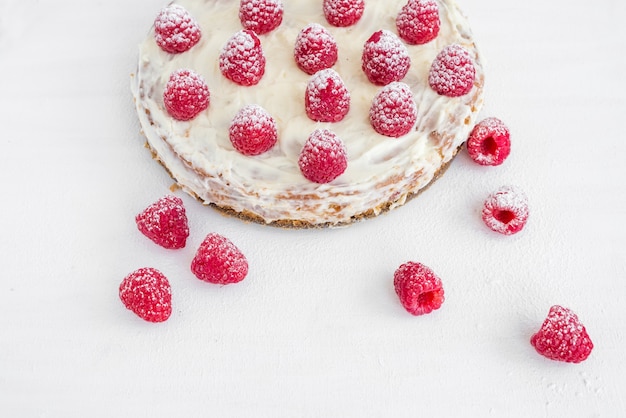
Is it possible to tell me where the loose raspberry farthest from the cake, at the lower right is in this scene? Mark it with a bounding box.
[530,305,593,363]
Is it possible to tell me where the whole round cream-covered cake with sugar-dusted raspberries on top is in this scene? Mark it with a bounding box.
[131,0,484,227]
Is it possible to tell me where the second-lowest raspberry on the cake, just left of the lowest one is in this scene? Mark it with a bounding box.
[229,105,278,155]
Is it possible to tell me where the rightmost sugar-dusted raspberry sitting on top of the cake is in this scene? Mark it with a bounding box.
[428,44,476,97]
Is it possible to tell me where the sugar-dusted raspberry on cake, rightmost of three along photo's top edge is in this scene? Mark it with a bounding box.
[396,0,441,45]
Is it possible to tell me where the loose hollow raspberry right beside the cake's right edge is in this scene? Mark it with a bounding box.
[467,117,511,166]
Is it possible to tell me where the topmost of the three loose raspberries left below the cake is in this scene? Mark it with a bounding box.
[135,195,189,249]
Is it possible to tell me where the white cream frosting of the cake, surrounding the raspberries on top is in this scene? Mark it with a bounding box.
[131,0,484,225]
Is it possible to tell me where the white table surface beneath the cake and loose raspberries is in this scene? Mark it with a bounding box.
[0,0,626,417]
